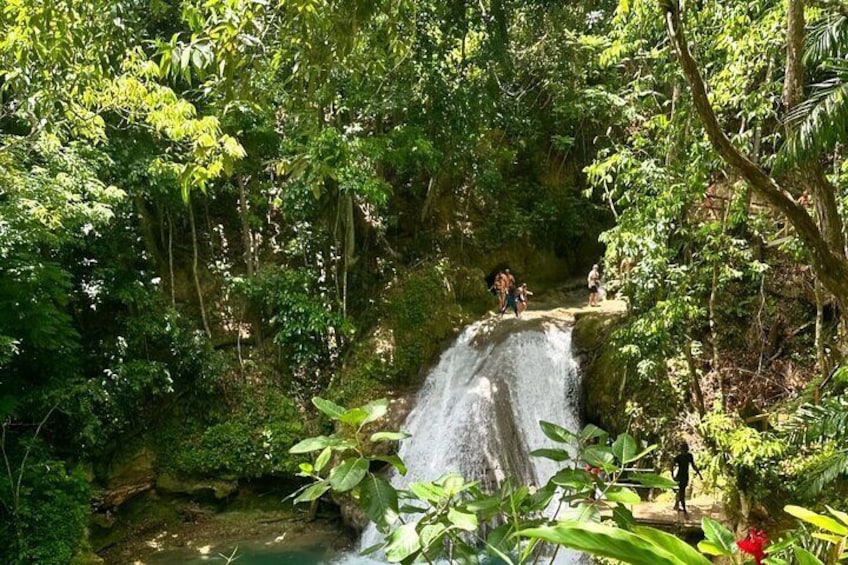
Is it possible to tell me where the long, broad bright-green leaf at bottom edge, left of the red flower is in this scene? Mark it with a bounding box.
[518,521,687,565]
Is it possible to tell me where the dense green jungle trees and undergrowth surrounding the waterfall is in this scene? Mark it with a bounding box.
[0,0,848,563]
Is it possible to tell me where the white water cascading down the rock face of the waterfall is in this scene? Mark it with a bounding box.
[354,319,580,563]
